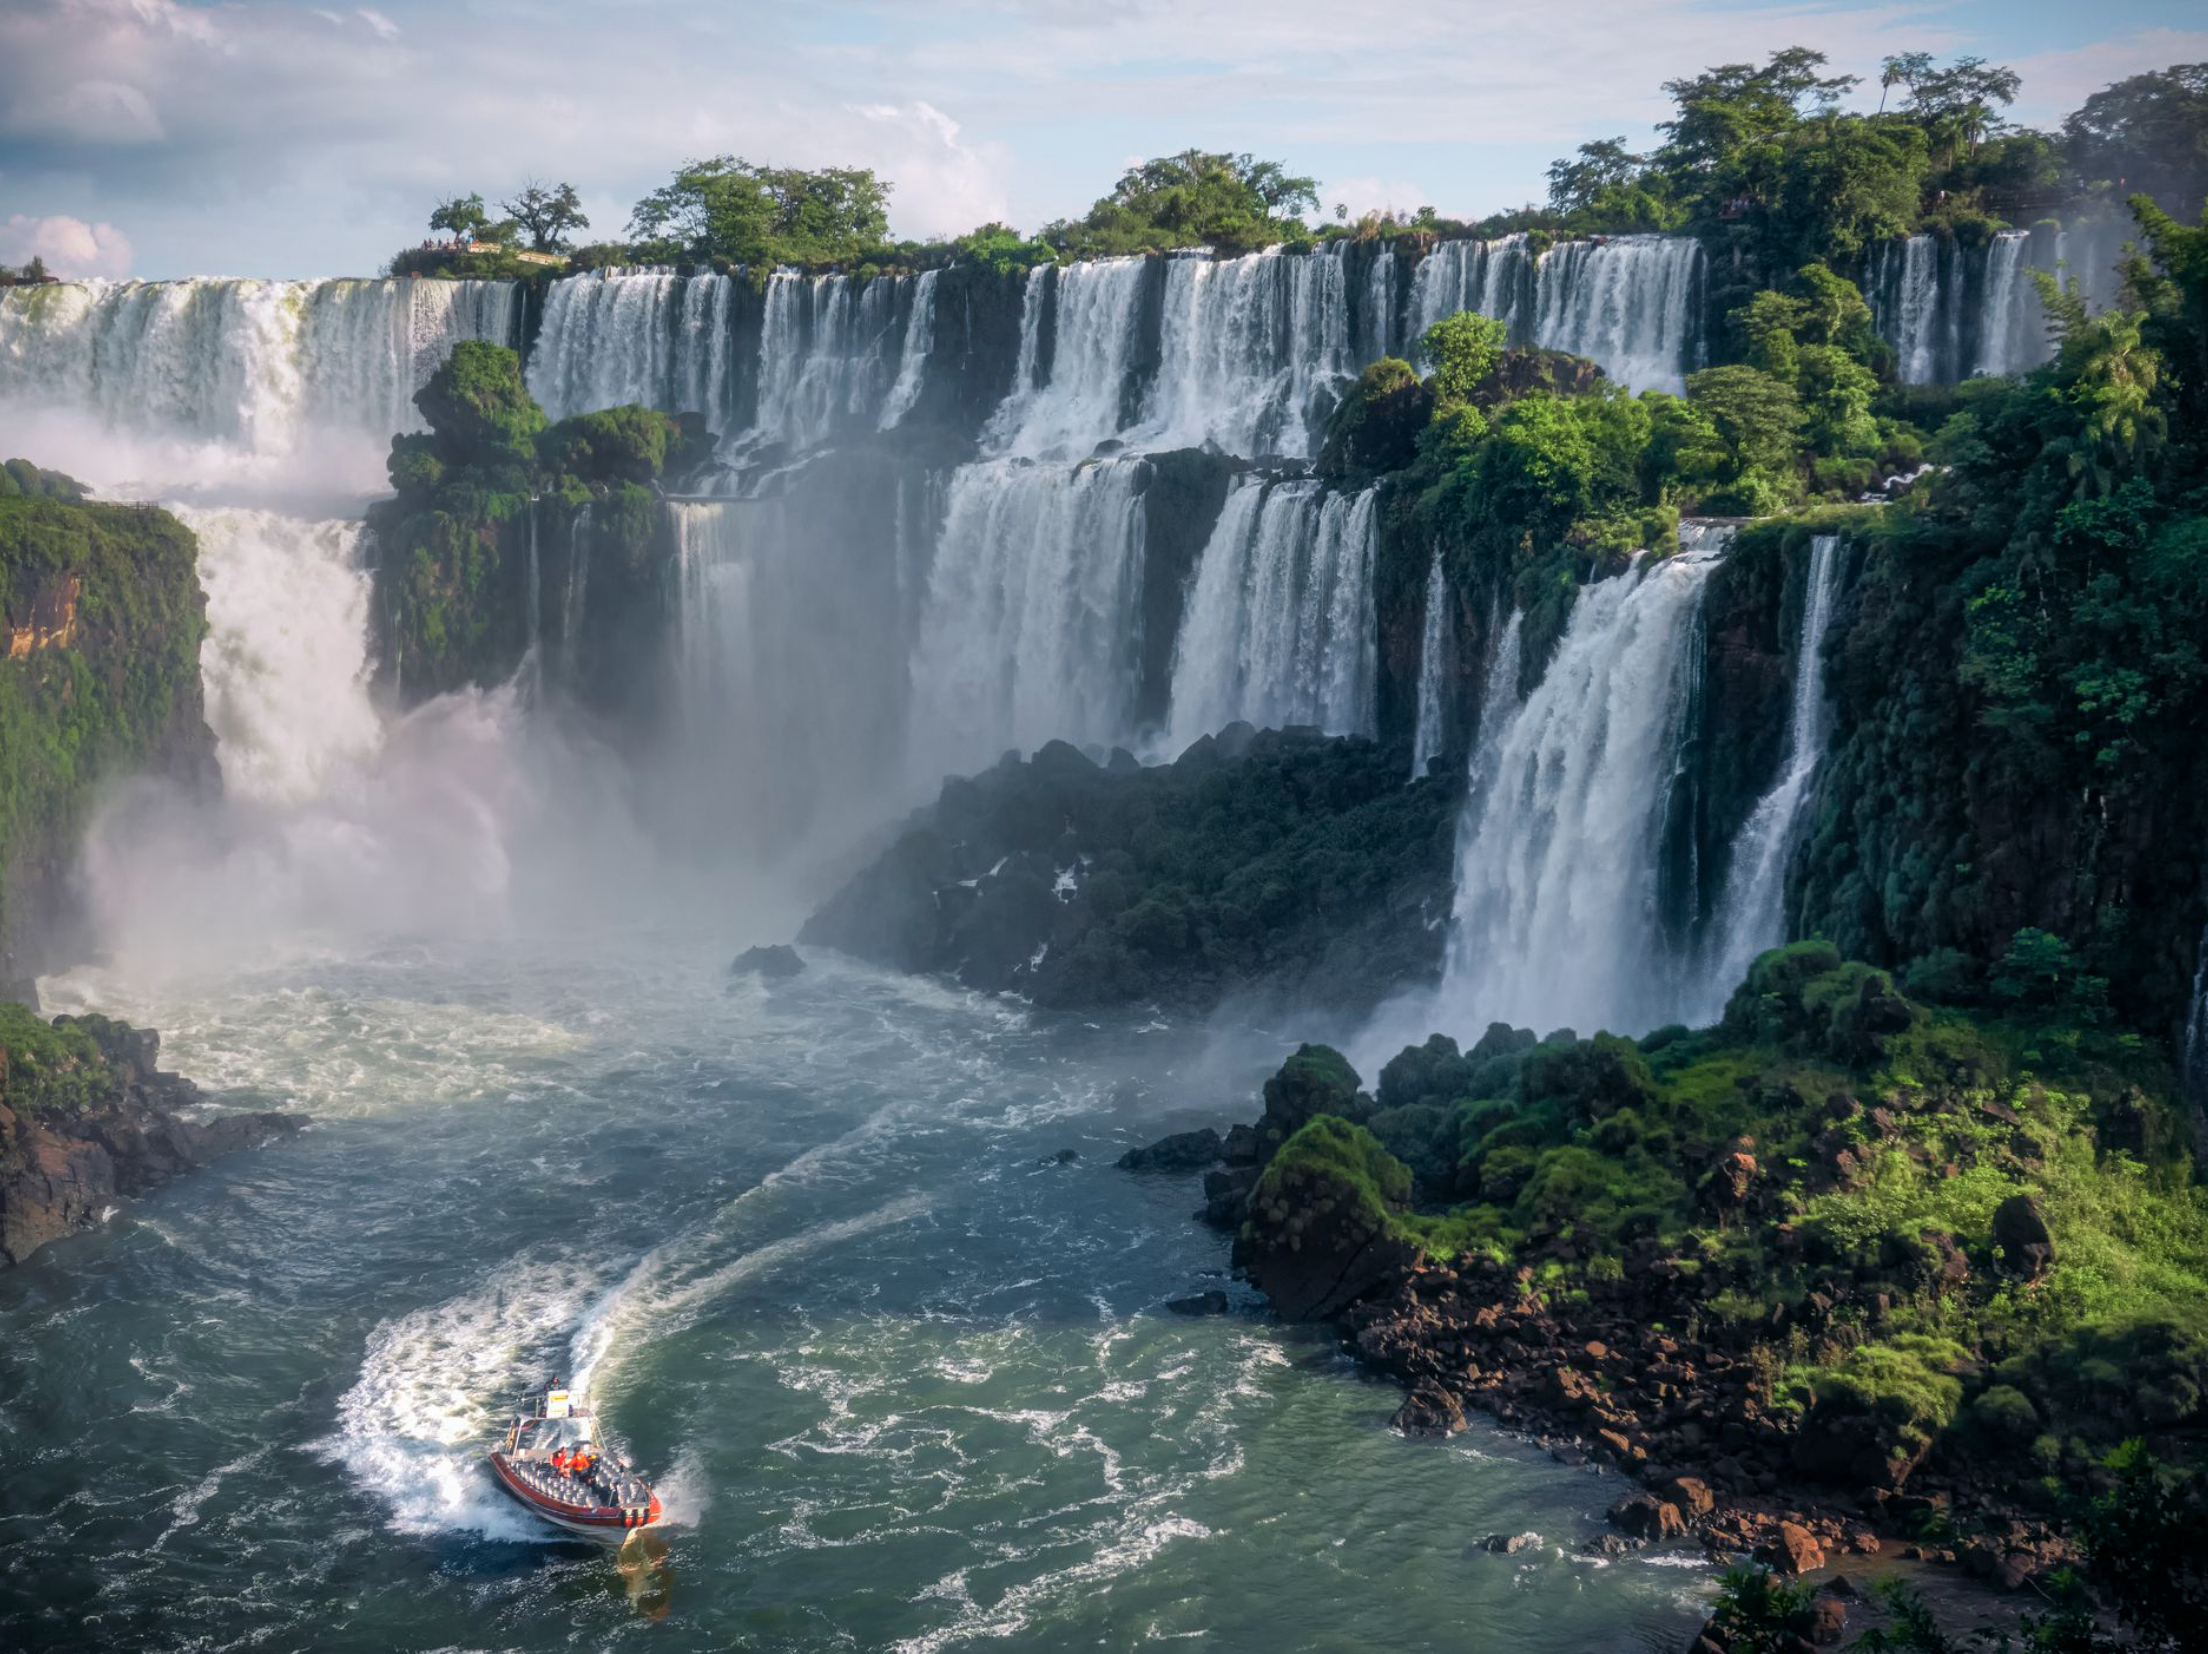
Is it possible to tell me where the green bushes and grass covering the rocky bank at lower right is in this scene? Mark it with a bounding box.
[1283,943,2208,1473]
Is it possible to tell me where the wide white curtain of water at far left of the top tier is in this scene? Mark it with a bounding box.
[0,280,519,481]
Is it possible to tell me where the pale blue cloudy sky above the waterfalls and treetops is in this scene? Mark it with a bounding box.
[0,0,2208,278]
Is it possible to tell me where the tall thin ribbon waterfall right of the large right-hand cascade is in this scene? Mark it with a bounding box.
[1705,534,1839,1018]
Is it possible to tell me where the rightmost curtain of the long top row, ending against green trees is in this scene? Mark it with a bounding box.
[1535,236,1702,395]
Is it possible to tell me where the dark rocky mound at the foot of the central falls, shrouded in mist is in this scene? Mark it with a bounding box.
[797,724,1462,1009]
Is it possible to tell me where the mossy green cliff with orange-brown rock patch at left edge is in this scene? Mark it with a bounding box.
[0,495,216,998]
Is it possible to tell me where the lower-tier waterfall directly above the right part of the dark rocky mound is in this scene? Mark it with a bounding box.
[1170,479,1380,749]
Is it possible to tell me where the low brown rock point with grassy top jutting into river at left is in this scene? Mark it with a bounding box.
[0,1005,305,1265]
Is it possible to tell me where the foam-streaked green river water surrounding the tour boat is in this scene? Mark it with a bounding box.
[0,930,1709,1652]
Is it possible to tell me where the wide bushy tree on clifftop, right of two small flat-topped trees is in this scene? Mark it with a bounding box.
[629,155,890,272]
